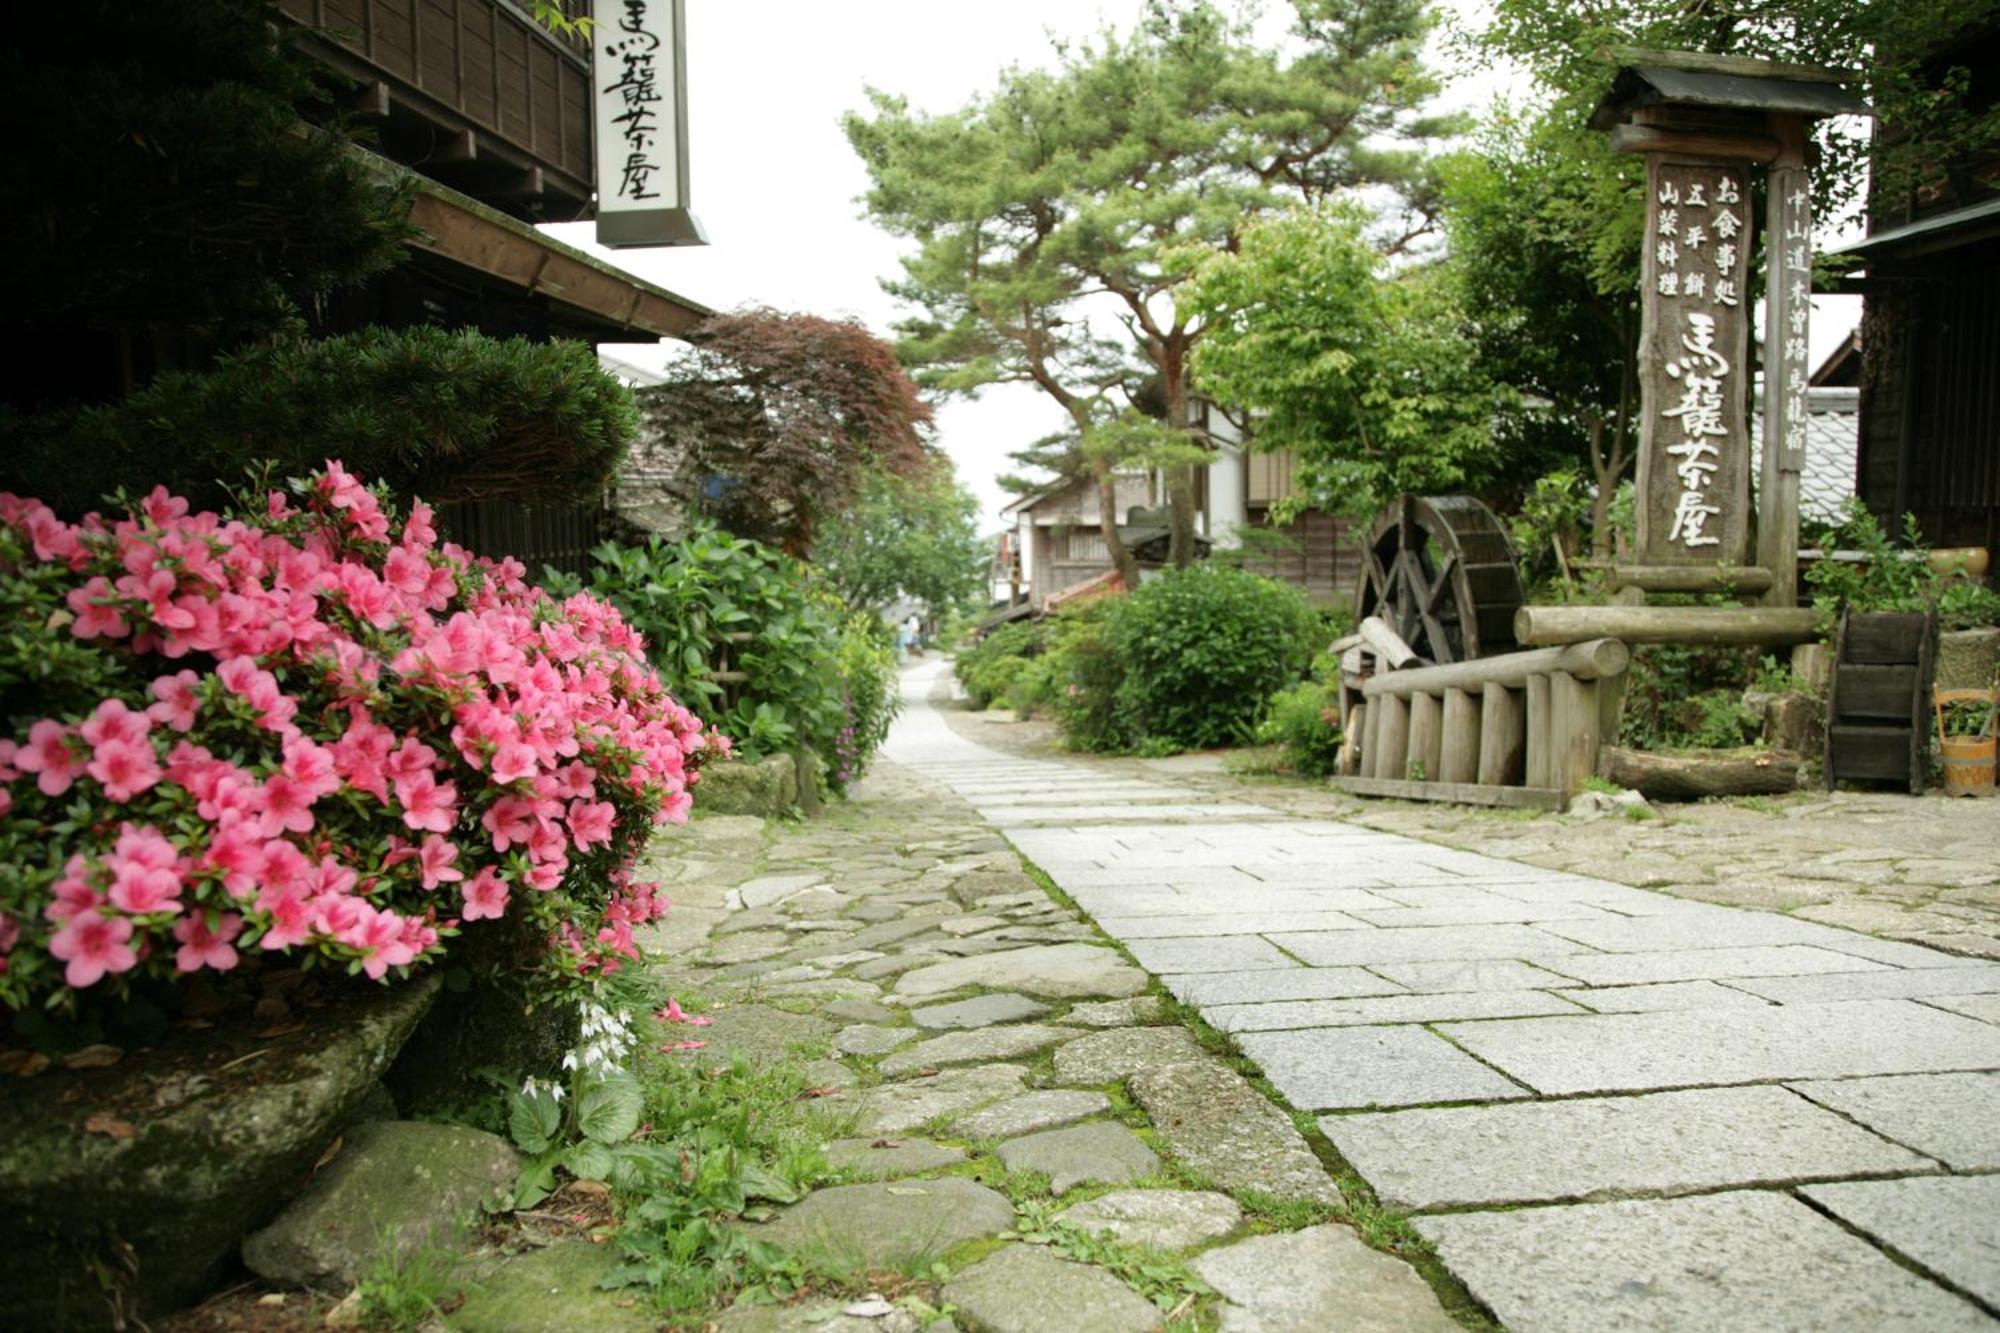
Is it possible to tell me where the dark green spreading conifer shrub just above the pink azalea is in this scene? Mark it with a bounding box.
[0,328,638,514]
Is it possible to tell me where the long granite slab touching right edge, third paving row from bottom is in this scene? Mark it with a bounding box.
[1440,1001,2000,1105]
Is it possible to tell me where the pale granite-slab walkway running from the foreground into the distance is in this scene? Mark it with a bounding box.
[886,662,2000,1331]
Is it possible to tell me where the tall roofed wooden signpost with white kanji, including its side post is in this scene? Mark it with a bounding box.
[1590,50,1866,608]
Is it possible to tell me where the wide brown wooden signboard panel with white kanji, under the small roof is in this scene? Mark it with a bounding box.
[1638,156,1752,564]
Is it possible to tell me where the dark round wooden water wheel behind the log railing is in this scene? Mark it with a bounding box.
[1354,494,1524,664]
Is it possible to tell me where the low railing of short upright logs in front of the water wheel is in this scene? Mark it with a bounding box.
[1334,638,1632,809]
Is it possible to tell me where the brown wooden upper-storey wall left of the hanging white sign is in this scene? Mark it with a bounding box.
[278,0,592,222]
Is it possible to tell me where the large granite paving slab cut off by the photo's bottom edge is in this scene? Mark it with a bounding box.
[1416,1191,2000,1333]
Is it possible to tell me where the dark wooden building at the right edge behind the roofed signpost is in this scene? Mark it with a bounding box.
[1844,22,2000,548]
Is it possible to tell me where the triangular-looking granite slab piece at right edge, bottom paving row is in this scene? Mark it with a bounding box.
[1800,1175,2000,1305]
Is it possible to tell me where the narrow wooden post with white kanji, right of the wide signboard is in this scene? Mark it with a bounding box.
[1756,114,1812,606]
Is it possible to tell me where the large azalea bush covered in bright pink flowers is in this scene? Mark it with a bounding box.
[0,462,728,1009]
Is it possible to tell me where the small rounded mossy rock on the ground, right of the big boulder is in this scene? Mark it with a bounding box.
[244,1121,520,1289]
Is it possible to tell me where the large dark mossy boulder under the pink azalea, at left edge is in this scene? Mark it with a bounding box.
[0,977,438,1329]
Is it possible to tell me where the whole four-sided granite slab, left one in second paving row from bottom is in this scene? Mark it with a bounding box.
[1320,1087,1936,1209]
